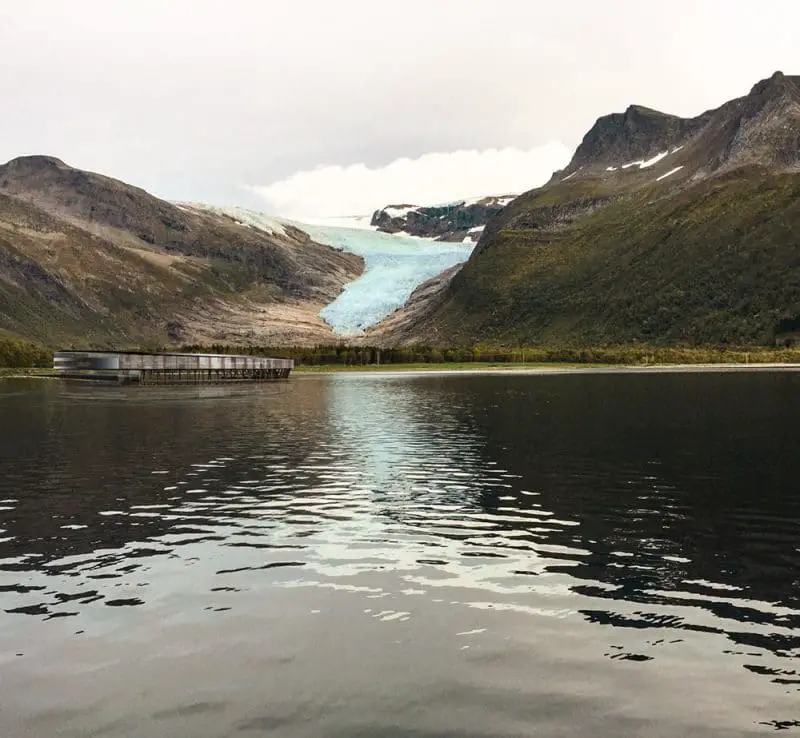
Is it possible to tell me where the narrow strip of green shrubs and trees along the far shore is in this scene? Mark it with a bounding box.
[0,338,800,370]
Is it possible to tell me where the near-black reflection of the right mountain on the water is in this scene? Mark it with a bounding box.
[432,375,800,655]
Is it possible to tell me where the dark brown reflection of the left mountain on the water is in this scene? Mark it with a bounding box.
[0,382,336,568]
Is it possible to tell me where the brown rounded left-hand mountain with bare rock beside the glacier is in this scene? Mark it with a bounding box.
[0,156,363,346]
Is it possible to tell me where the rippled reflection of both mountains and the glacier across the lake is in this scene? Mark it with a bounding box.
[0,373,800,689]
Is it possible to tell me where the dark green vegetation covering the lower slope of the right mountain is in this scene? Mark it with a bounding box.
[432,167,800,351]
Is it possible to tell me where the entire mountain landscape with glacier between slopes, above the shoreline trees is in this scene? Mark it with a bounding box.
[0,72,800,354]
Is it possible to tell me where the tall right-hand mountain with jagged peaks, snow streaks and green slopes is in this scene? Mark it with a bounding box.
[367,72,800,346]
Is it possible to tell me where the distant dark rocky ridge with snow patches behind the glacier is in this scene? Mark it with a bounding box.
[370,195,514,243]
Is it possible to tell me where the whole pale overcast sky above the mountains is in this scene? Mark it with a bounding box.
[0,0,800,217]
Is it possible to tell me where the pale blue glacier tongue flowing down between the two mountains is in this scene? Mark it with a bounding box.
[297,223,475,335]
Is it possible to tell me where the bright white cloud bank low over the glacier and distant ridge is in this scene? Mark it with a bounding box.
[250,142,572,218]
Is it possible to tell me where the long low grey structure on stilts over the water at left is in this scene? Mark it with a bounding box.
[53,351,294,385]
